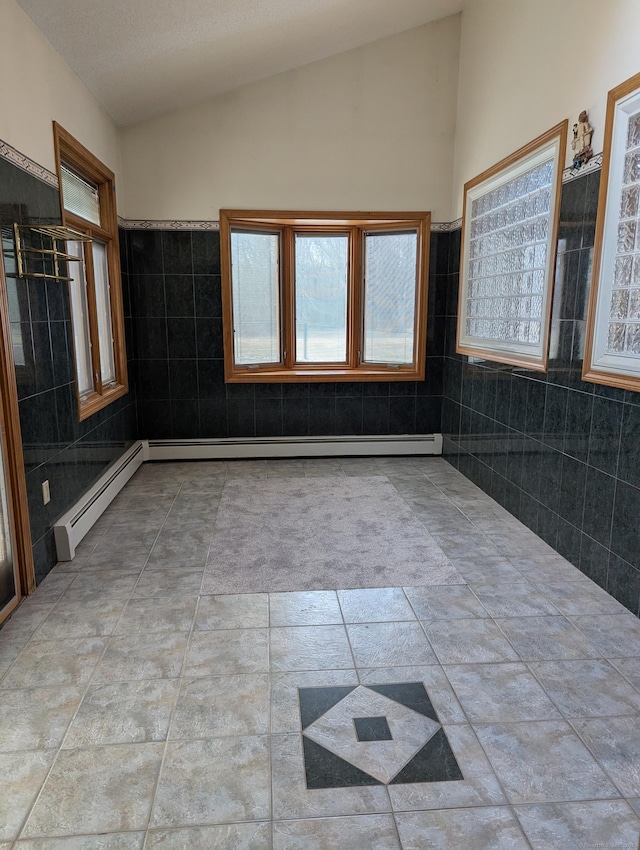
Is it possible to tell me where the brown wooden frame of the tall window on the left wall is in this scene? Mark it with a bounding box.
[53,121,129,420]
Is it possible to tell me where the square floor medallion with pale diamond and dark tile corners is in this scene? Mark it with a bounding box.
[298,682,464,790]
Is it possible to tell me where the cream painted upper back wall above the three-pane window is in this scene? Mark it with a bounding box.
[120,15,460,221]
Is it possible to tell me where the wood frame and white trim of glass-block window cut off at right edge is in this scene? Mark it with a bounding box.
[582,74,640,392]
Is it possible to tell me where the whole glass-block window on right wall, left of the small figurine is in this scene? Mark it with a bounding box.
[458,123,566,369]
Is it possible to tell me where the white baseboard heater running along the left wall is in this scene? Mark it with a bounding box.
[53,440,147,561]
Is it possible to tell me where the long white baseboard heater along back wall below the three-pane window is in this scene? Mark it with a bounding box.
[148,434,442,460]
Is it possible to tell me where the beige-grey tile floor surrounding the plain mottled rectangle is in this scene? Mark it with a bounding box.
[0,458,640,850]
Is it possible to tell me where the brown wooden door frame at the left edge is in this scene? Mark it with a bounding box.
[0,242,36,621]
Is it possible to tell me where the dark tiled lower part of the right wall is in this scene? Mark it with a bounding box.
[442,171,640,614]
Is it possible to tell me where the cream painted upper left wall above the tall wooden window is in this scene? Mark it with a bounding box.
[0,0,119,173]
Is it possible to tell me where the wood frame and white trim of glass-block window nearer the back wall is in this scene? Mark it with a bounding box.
[456,120,568,372]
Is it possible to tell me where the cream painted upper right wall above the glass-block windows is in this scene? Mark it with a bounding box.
[452,0,640,218]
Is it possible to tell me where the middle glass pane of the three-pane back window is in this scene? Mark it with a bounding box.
[295,233,349,363]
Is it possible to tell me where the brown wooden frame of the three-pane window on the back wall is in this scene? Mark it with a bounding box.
[220,209,431,383]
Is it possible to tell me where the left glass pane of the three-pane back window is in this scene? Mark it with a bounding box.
[231,230,281,366]
